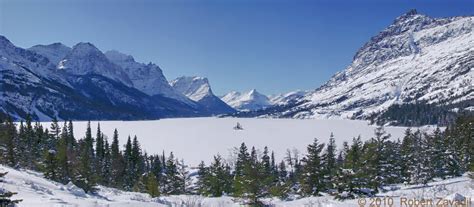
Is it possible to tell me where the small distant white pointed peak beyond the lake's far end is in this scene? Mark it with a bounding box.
[221,89,271,111]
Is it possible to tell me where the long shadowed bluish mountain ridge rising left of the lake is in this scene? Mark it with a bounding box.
[0,36,209,120]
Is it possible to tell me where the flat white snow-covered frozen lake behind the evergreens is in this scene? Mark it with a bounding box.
[39,117,428,166]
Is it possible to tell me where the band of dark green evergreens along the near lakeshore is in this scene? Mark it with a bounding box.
[0,116,474,205]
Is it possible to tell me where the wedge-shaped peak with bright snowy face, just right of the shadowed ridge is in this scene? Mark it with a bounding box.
[170,76,235,114]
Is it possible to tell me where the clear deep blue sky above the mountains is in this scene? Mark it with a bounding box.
[0,0,474,94]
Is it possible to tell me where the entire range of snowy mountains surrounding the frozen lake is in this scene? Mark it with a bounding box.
[0,10,474,120]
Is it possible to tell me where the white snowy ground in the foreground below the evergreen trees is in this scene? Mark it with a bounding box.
[0,165,474,207]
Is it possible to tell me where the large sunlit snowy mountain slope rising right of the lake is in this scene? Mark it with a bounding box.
[262,10,474,118]
